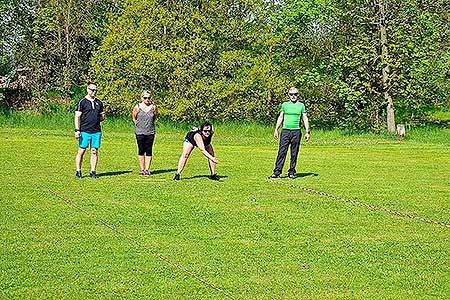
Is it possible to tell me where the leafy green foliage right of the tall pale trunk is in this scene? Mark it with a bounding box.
[388,0,450,123]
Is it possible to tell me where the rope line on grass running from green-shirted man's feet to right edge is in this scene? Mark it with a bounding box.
[272,181,450,228]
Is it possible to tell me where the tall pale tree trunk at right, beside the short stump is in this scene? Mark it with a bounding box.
[375,0,395,133]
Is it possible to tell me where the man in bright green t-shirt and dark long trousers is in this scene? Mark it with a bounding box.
[269,87,310,179]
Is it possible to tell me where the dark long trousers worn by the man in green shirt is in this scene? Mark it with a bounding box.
[273,129,302,175]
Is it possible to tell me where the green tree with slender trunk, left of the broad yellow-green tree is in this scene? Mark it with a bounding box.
[15,0,118,94]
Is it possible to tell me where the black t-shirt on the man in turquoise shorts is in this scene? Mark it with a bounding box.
[75,98,104,133]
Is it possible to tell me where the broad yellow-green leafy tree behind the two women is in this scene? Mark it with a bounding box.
[92,0,284,120]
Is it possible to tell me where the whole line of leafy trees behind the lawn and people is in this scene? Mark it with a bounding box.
[0,0,450,132]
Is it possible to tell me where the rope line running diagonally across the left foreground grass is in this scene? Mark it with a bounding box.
[38,184,234,299]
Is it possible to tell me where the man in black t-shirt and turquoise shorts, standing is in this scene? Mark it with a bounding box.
[75,82,106,179]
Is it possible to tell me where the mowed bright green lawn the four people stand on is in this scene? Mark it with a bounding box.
[0,125,450,299]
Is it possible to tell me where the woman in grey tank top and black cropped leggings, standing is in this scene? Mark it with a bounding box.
[133,90,158,176]
